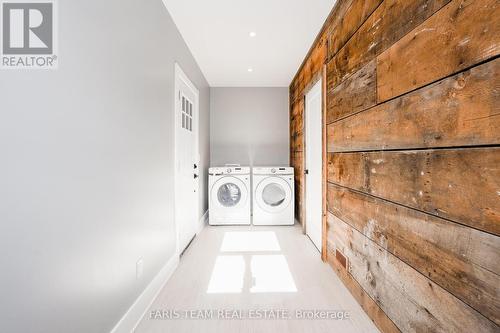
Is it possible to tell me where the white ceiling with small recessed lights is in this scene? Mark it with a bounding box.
[163,0,336,87]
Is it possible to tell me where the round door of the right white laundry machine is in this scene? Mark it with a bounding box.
[255,177,292,213]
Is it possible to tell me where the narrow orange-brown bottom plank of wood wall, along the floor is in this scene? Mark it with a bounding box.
[327,241,401,333]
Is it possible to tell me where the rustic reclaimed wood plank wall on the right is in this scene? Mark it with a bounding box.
[290,0,500,332]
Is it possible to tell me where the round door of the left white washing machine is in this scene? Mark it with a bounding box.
[210,176,248,208]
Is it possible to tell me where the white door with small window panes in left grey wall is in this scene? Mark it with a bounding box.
[175,64,200,254]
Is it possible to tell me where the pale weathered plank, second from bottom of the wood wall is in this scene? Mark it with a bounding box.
[329,214,498,332]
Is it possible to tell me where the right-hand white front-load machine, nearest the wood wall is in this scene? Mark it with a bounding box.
[252,167,295,225]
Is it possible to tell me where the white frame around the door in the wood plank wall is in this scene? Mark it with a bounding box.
[304,76,325,256]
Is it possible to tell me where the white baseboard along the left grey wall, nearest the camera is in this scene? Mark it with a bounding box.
[111,254,179,333]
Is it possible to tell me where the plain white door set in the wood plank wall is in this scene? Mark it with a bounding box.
[305,80,323,252]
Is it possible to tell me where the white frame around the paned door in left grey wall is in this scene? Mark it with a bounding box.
[174,62,201,256]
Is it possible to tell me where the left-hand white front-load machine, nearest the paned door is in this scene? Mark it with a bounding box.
[208,166,251,225]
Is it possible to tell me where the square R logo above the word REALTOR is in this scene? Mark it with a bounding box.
[2,1,54,55]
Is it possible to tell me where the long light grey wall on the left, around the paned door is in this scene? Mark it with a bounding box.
[0,0,209,332]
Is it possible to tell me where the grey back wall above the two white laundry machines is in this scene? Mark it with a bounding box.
[210,88,290,166]
